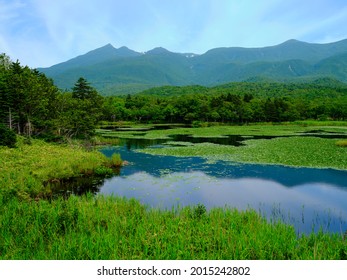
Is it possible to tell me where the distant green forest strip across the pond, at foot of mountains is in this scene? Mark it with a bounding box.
[103,83,347,123]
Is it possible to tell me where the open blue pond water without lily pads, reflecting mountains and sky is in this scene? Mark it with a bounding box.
[49,131,347,233]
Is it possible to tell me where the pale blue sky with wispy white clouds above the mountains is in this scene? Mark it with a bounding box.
[0,0,347,68]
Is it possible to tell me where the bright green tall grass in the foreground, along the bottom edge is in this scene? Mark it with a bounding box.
[0,196,347,260]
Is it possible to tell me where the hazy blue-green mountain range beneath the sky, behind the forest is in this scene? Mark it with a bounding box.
[38,39,347,95]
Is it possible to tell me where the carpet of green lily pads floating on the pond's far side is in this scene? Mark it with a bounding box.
[119,123,347,170]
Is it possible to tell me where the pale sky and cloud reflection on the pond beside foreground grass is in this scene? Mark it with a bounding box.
[101,171,347,232]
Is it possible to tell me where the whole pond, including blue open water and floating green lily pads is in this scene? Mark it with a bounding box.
[51,126,347,233]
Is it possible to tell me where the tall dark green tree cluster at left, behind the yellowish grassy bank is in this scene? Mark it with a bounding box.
[0,54,103,146]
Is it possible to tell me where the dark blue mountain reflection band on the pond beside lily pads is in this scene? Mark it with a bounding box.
[102,147,347,188]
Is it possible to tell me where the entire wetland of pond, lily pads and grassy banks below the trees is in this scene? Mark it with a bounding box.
[0,125,347,260]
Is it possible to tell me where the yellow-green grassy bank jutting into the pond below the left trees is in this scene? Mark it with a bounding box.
[0,139,121,199]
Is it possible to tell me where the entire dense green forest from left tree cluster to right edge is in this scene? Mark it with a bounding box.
[0,54,347,146]
